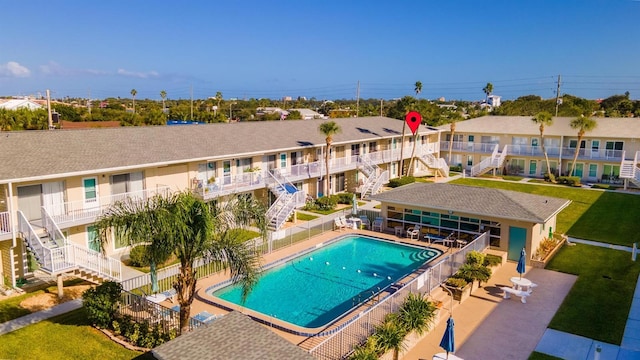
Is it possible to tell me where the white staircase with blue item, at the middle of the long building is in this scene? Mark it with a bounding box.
[267,169,307,231]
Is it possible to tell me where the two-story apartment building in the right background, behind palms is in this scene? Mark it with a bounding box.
[440,116,640,186]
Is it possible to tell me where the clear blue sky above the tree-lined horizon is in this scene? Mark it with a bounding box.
[0,0,640,100]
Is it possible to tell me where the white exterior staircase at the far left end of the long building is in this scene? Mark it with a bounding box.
[18,208,122,283]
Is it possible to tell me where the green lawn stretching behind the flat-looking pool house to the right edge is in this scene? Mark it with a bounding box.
[451,178,640,246]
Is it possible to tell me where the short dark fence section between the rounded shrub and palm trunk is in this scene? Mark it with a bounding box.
[117,291,205,335]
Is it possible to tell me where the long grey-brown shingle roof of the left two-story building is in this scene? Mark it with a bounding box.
[0,117,434,183]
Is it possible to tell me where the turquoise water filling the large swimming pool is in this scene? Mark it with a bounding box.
[211,236,441,328]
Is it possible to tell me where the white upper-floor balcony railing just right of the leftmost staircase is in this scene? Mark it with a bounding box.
[44,186,170,228]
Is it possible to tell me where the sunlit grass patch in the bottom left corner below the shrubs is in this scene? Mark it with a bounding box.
[0,309,146,360]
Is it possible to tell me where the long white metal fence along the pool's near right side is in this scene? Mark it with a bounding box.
[309,232,489,360]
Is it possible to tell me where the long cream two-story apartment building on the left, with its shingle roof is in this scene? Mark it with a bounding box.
[0,117,448,284]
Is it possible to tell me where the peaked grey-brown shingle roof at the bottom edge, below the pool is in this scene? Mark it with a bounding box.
[153,311,314,360]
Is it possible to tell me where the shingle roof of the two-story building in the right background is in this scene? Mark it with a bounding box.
[438,116,640,141]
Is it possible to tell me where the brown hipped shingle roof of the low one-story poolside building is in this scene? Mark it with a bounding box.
[371,183,571,223]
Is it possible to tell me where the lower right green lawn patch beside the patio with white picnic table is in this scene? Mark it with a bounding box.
[546,244,640,345]
